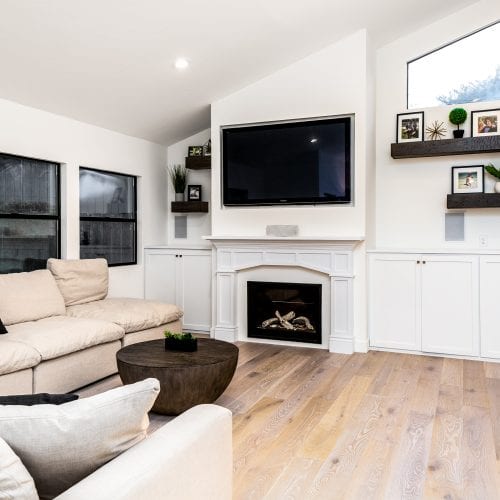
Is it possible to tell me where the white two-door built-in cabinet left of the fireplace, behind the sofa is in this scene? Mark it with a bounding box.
[144,247,212,332]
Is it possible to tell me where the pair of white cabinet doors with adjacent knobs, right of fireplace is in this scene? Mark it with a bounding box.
[368,253,478,356]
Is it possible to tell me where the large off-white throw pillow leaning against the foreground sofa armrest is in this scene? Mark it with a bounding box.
[0,378,160,498]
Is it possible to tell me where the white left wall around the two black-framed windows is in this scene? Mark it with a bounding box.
[0,100,167,297]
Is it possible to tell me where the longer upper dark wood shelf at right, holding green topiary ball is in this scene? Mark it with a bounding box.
[391,135,500,159]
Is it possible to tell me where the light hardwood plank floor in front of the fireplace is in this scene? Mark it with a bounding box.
[77,343,500,500]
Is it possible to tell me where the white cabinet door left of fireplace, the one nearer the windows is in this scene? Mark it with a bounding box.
[144,251,180,305]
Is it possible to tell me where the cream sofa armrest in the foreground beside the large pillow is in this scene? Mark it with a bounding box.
[57,405,233,500]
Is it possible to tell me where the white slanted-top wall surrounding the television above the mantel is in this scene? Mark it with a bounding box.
[211,30,370,236]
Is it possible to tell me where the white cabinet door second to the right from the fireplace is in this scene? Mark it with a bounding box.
[421,255,479,356]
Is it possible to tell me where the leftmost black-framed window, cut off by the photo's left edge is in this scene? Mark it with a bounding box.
[0,153,61,274]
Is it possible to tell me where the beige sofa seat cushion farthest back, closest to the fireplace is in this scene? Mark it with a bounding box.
[67,299,183,333]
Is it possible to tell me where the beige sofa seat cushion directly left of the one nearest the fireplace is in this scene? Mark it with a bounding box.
[7,316,125,361]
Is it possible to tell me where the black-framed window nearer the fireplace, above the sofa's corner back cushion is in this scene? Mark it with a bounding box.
[80,167,137,266]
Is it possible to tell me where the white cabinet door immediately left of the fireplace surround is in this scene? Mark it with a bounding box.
[179,250,212,332]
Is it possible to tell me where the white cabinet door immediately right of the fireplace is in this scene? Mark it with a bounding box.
[368,254,420,350]
